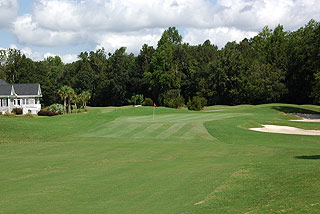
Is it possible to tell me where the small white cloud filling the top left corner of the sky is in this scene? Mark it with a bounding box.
[0,0,19,29]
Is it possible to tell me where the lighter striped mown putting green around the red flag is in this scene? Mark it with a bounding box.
[80,113,250,140]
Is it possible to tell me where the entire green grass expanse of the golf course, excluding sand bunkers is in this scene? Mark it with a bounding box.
[0,104,320,214]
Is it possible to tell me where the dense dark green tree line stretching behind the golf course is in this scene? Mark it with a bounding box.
[0,20,320,106]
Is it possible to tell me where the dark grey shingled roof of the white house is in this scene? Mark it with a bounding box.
[0,79,41,96]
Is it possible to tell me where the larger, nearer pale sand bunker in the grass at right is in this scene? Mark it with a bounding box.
[250,125,320,135]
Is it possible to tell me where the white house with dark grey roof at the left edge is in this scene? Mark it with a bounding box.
[0,79,42,114]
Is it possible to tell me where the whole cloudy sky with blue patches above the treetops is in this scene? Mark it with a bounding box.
[0,0,320,63]
